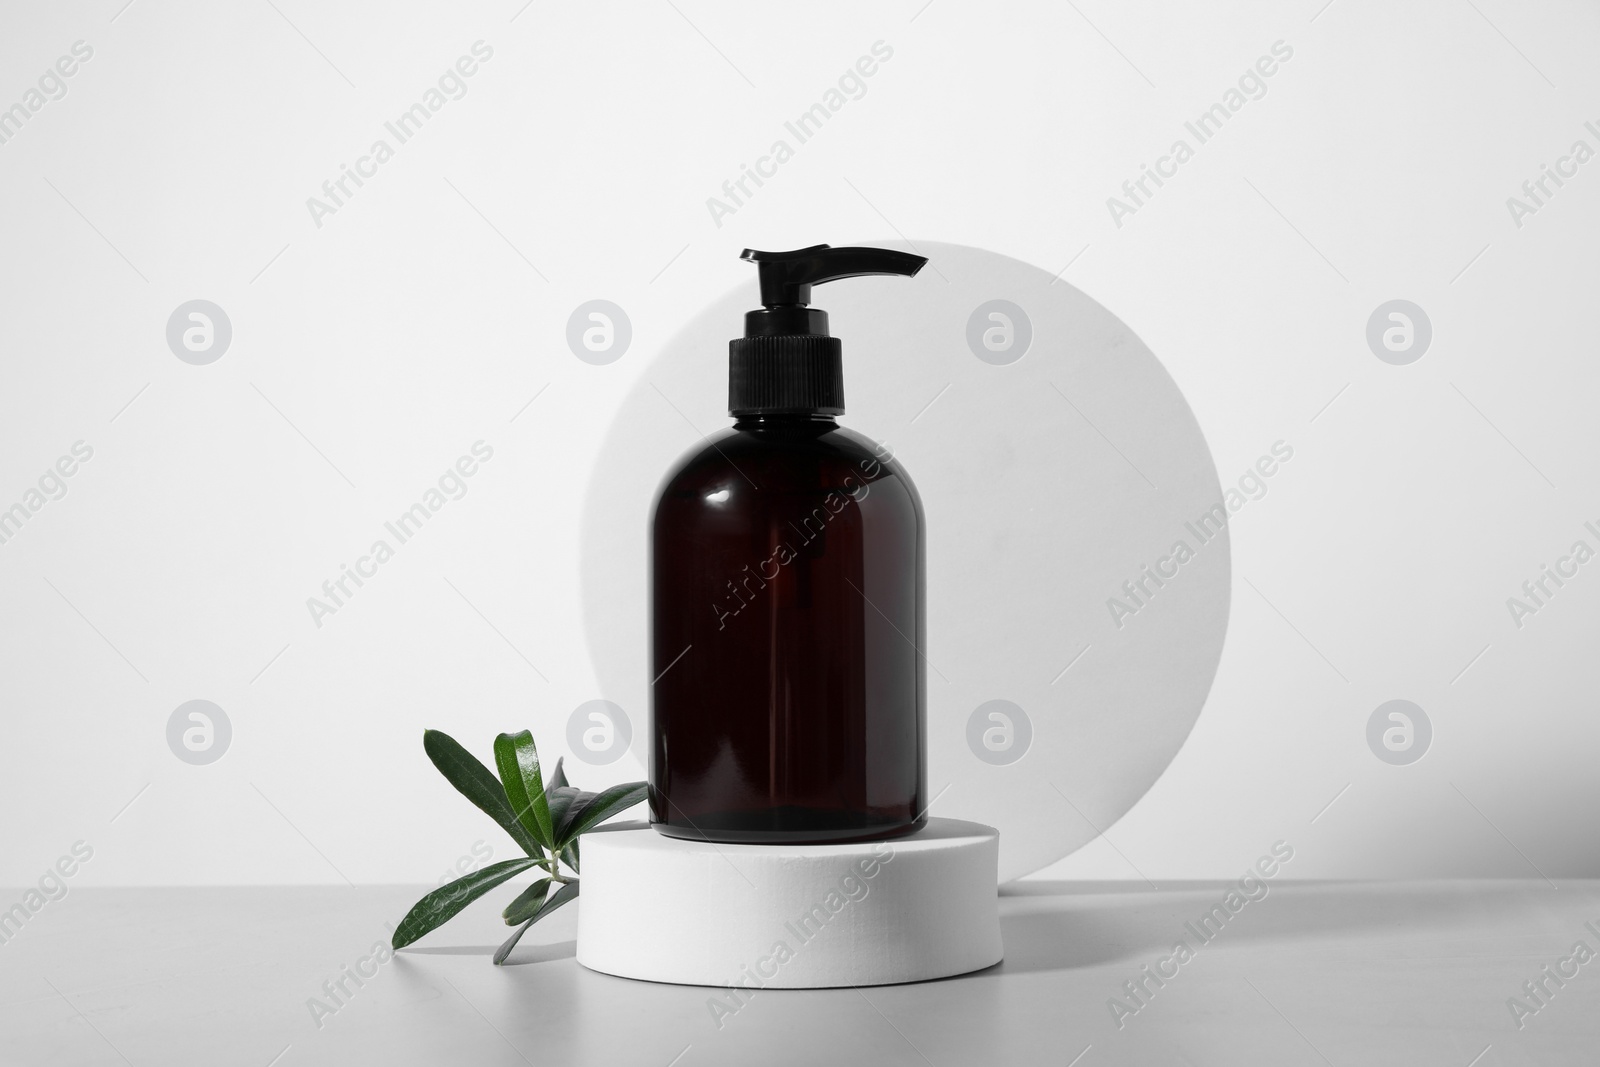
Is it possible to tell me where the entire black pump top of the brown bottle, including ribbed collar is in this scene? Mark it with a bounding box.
[728,245,928,418]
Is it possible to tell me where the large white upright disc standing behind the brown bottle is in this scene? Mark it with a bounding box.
[581,242,1230,880]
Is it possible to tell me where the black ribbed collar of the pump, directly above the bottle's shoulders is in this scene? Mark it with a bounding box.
[728,333,845,418]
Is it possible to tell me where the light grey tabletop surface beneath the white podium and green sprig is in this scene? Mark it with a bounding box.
[0,880,1600,1067]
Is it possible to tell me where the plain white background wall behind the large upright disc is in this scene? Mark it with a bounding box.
[0,0,1600,885]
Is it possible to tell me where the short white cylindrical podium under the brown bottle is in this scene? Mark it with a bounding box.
[578,819,1002,991]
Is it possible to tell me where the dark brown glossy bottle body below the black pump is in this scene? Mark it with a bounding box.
[650,416,926,843]
